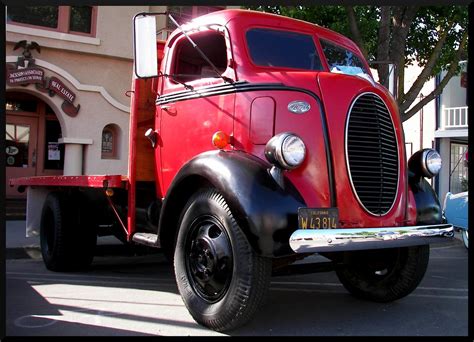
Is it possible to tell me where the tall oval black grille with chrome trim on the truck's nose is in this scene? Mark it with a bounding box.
[346,93,399,216]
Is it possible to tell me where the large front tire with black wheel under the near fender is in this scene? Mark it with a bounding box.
[174,189,272,331]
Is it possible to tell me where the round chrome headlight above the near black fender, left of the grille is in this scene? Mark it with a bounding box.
[265,132,306,170]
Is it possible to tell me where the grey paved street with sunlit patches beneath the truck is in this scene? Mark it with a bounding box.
[6,222,468,336]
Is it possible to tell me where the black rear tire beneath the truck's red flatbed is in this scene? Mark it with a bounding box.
[40,192,97,272]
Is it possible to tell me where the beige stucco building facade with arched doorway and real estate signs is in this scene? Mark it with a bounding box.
[4,6,231,198]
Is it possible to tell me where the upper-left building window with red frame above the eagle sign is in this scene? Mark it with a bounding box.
[7,6,97,36]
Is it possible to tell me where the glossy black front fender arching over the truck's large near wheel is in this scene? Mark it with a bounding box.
[158,151,305,257]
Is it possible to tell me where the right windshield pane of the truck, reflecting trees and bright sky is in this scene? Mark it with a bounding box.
[321,39,369,75]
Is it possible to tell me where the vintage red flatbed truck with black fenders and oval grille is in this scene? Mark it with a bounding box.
[11,10,453,331]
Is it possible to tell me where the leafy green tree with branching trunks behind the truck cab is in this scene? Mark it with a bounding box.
[246,4,468,121]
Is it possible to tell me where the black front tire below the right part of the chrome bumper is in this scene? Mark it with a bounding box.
[336,245,430,303]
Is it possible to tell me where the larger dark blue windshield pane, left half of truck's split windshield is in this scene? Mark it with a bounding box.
[246,28,323,70]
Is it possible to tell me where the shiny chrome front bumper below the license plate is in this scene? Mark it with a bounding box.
[290,224,454,253]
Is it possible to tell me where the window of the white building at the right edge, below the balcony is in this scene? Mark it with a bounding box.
[449,143,469,194]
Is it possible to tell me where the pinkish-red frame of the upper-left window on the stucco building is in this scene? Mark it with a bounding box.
[6,6,99,38]
